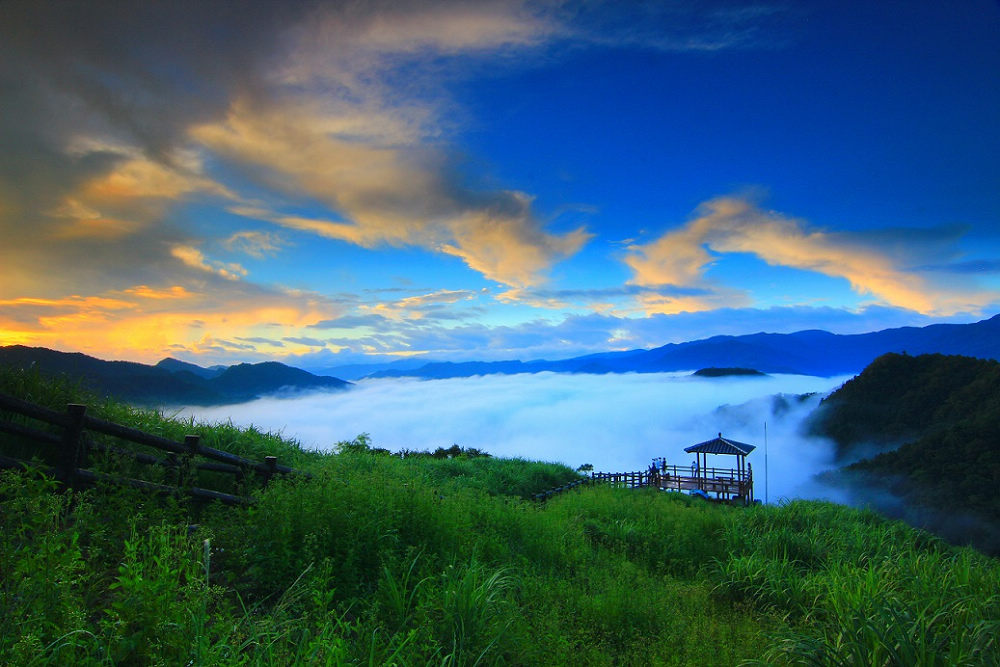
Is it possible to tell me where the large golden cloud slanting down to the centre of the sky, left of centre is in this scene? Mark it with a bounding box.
[201,102,591,287]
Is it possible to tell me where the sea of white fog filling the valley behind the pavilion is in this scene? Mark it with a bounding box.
[181,373,850,502]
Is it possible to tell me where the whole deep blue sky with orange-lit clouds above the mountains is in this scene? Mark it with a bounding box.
[0,0,1000,368]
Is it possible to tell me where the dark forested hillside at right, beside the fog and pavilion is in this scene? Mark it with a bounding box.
[813,354,1000,554]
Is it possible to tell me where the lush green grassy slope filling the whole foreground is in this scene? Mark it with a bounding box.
[0,368,1000,665]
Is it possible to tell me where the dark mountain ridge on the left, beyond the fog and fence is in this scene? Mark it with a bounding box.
[0,345,351,405]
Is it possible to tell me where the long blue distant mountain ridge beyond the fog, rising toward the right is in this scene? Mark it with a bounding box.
[368,315,1000,378]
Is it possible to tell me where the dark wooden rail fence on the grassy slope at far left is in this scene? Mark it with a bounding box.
[0,394,307,505]
